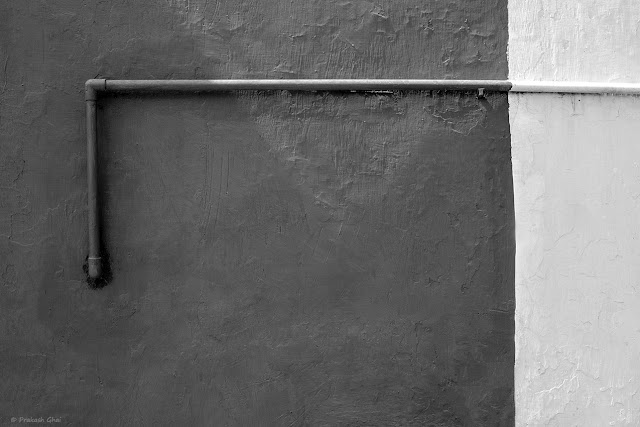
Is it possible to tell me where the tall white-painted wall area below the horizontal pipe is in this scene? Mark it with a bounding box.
[509,95,640,426]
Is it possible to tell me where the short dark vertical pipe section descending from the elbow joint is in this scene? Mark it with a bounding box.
[85,93,102,280]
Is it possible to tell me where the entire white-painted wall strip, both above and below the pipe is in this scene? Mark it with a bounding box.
[509,0,640,426]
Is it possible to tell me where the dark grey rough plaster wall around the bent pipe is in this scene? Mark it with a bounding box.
[0,0,514,425]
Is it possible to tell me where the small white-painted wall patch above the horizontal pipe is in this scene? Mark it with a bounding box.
[509,0,640,83]
